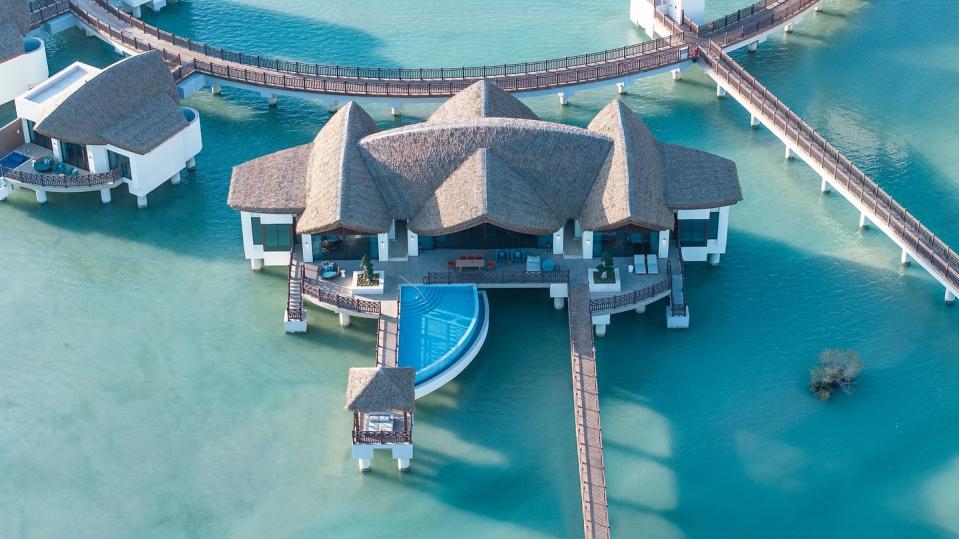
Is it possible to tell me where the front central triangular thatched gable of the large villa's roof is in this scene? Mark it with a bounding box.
[408,148,566,236]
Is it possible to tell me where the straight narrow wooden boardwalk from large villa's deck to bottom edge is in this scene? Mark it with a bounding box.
[569,282,610,539]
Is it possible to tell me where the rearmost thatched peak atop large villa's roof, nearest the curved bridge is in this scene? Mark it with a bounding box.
[427,79,539,124]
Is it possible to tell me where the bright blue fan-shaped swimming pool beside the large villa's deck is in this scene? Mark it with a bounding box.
[398,285,481,384]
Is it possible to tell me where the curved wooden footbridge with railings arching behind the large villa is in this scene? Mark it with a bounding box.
[82,0,684,81]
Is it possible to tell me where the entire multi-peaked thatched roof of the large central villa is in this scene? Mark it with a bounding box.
[229,81,741,235]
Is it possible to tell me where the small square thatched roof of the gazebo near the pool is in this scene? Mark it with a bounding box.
[346,367,416,413]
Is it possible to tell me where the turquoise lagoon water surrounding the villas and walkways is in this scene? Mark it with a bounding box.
[0,0,959,538]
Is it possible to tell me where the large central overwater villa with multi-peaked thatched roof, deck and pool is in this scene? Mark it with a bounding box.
[229,81,742,397]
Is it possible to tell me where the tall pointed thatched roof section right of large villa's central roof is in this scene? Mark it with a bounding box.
[579,100,673,230]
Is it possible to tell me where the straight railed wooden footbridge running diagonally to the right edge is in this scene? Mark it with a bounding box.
[700,42,959,288]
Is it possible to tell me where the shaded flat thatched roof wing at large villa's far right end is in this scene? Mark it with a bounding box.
[659,143,743,210]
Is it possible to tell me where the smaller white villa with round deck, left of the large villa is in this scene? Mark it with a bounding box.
[0,52,203,208]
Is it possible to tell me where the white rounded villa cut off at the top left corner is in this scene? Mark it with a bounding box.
[0,0,49,105]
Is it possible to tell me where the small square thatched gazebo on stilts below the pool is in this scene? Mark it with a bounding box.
[346,367,416,471]
